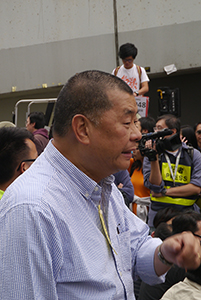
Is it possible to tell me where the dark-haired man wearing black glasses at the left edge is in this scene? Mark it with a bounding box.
[0,127,38,198]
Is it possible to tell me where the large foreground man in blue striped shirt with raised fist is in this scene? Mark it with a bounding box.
[0,71,201,300]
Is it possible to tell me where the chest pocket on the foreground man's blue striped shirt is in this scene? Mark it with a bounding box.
[117,230,131,271]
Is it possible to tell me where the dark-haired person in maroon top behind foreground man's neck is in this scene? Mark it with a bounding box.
[26,111,49,155]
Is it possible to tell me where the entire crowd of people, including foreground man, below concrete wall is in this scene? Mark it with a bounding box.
[0,43,201,300]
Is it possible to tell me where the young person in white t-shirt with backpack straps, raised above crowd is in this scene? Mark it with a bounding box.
[112,43,149,97]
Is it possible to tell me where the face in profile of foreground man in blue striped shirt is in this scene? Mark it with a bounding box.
[87,90,141,182]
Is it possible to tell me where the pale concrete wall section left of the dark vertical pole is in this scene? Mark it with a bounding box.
[0,0,114,93]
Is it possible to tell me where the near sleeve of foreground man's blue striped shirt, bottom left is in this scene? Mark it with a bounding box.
[0,205,62,300]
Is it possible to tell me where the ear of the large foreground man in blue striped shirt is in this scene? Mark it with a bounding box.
[72,115,90,144]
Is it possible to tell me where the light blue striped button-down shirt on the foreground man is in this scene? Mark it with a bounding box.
[0,142,162,300]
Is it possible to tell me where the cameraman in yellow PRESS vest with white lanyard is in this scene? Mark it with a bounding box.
[143,115,201,230]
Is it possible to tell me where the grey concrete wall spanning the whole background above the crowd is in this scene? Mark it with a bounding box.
[0,0,201,124]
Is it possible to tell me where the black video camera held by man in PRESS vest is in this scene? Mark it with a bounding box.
[139,128,182,161]
